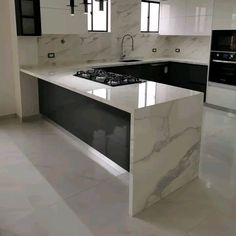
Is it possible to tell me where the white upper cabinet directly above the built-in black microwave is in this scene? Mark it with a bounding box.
[213,0,236,30]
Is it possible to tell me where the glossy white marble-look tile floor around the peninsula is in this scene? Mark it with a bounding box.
[0,108,236,236]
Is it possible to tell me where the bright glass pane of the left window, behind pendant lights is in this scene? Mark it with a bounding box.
[93,0,107,31]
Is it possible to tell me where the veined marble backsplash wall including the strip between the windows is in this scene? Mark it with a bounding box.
[38,0,210,64]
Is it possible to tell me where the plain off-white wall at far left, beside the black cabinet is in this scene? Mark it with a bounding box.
[0,0,17,116]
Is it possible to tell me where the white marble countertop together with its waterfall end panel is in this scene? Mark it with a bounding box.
[21,58,203,216]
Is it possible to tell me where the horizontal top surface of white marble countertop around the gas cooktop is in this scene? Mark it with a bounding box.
[20,58,206,113]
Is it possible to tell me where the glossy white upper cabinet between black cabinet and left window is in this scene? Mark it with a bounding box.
[40,0,87,34]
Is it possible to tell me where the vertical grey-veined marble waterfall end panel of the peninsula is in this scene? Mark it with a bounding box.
[130,94,203,216]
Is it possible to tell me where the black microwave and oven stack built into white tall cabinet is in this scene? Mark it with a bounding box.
[209,30,236,86]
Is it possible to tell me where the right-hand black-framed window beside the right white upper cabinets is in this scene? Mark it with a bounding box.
[141,0,160,33]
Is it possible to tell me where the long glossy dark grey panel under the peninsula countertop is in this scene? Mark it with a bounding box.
[39,80,130,171]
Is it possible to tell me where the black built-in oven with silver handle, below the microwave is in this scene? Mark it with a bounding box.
[209,52,236,85]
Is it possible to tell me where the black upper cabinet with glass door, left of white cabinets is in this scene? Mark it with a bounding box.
[15,0,41,36]
